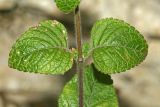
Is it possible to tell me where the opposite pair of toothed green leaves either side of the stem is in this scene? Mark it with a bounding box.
[9,18,148,74]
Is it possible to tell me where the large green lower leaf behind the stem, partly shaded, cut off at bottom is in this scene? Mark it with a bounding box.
[59,66,118,107]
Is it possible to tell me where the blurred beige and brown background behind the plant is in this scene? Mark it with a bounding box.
[0,0,160,107]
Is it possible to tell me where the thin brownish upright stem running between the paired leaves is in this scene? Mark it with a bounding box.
[74,7,83,107]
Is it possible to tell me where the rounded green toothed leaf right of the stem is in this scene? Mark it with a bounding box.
[91,18,148,74]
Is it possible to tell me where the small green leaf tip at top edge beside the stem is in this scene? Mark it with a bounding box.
[55,0,80,13]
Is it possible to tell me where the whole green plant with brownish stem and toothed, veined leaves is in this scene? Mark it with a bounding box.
[8,0,148,107]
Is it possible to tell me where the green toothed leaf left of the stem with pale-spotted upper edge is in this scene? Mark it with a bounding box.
[9,20,73,74]
